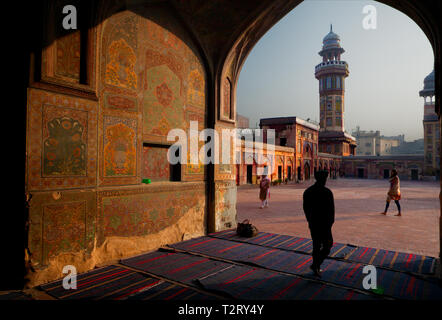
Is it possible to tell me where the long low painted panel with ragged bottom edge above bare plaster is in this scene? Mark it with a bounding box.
[98,182,205,242]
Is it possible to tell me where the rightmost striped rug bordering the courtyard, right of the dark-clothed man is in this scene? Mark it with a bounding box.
[345,247,436,274]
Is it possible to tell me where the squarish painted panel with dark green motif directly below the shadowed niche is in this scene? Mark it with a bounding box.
[27,89,97,190]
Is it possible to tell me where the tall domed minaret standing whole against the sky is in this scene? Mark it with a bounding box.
[315,24,356,156]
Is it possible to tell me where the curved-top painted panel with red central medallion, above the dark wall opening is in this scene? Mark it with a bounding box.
[142,20,206,141]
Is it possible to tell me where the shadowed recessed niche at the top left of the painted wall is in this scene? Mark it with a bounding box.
[39,0,97,92]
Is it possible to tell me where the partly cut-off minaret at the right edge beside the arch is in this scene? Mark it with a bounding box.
[419,70,440,176]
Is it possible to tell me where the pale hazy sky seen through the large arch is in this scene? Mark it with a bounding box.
[237,0,434,141]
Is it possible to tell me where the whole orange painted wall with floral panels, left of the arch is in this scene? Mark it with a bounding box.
[26,8,208,286]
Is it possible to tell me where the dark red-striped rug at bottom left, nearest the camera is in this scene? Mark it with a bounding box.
[40,265,218,300]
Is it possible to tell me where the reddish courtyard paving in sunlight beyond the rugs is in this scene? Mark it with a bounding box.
[237,178,440,257]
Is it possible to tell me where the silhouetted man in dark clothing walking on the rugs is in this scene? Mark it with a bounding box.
[303,171,335,276]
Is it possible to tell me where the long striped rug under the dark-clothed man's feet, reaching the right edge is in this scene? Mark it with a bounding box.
[170,237,442,299]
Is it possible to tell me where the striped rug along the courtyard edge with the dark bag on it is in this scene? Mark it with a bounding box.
[208,229,356,258]
